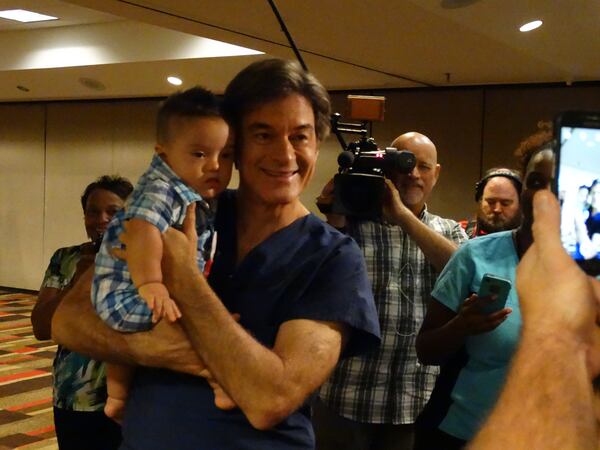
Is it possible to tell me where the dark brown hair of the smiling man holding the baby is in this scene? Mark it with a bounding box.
[223,59,331,141]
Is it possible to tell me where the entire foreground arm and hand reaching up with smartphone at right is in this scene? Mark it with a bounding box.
[469,191,600,450]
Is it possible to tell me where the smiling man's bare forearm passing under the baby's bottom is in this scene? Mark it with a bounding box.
[52,267,204,375]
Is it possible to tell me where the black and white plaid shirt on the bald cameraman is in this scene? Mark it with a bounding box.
[319,209,467,424]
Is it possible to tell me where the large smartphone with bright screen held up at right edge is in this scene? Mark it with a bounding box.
[554,111,600,277]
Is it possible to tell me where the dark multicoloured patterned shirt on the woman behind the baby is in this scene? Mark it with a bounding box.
[41,245,107,411]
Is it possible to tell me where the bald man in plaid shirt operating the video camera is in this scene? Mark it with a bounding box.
[314,132,467,450]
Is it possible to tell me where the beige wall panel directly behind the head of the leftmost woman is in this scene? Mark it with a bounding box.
[44,101,155,278]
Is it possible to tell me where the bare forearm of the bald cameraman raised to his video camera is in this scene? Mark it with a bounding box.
[384,178,458,272]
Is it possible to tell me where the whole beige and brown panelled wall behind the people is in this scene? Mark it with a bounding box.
[0,86,600,289]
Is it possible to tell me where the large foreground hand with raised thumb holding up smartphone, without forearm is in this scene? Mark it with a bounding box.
[517,190,600,378]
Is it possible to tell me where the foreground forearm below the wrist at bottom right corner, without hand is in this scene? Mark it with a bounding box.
[469,332,598,450]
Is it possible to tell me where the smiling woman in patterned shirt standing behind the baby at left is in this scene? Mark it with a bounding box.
[31,175,133,450]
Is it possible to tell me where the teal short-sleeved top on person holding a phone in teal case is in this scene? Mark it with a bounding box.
[432,231,521,440]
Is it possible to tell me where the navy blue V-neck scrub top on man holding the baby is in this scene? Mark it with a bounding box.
[123,191,379,450]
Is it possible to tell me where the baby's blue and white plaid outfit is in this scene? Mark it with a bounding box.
[92,155,214,332]
